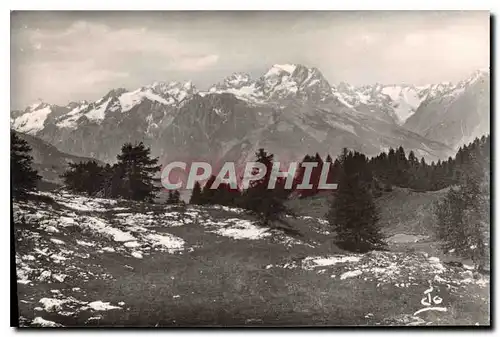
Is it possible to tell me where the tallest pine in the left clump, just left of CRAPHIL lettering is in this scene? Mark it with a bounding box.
[116,142,161,201]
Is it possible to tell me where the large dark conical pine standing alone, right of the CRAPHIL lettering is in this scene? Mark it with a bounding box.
[327,149,385,252]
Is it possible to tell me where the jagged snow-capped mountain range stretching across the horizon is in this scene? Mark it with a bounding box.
[11,64,490,167]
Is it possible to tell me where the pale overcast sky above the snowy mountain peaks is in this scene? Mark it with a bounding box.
[11,11,490,108]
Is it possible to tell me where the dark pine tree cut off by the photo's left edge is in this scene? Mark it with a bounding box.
[10,132,41,199]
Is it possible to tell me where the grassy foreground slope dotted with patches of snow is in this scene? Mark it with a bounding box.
[15,191,489,326]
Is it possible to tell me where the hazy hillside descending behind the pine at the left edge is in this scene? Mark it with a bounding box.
[13,132,102,184]
